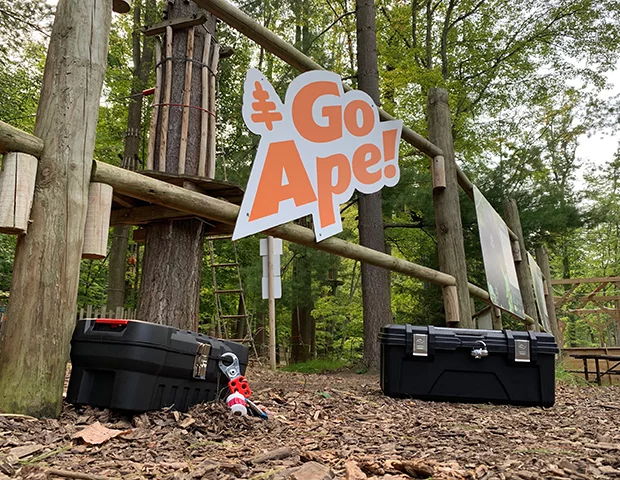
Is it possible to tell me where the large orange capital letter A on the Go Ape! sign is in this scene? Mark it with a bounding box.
[249,140,316,222]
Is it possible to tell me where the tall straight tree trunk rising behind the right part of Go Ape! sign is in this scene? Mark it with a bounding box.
[355,0,392,370]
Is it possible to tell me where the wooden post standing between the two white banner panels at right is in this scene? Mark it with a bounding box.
[504,198,538,330]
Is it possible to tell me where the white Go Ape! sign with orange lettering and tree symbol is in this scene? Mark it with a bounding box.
[233,69,402,241]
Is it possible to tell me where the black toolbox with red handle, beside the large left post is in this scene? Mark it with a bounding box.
[67,318,248,412]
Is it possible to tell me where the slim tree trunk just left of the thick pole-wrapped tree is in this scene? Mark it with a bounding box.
[107,0,156,312]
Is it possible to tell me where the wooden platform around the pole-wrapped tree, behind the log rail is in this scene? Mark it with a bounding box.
[110,170,244,237]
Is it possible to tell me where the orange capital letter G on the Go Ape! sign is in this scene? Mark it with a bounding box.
[291,82,342,143]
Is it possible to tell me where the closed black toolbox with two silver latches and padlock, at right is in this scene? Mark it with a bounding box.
[379,325,558,407]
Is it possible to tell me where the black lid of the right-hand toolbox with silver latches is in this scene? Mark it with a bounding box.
[379,324,559,361]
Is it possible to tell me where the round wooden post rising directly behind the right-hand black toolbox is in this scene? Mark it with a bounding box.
[428,88,474,328]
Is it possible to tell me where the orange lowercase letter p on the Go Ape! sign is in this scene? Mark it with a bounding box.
[316,153,351,228]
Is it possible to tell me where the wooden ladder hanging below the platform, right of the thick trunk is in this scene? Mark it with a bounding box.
[207,235,258,358]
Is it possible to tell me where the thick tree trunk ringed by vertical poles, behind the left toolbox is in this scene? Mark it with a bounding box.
[138,2,215,330]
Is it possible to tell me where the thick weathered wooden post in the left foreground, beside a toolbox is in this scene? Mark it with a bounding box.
[0,0,112,417]
